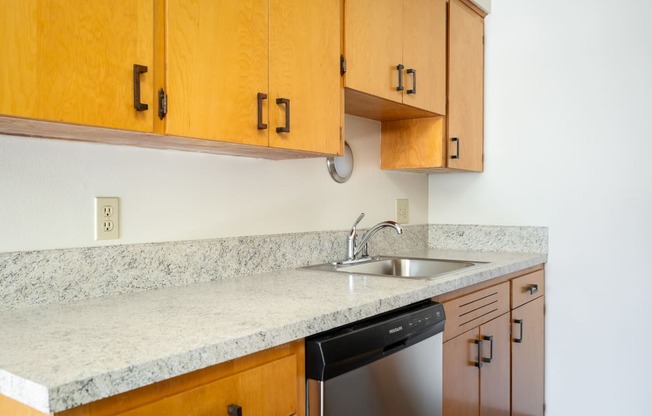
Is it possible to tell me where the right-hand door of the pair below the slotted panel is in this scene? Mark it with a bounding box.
[480,313,511,416]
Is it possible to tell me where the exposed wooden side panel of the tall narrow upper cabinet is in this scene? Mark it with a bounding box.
[380,117,445,169]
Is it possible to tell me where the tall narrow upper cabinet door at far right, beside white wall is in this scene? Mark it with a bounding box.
[447,0,484,171]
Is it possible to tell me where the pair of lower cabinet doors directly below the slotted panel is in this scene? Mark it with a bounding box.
[443,313,510,416]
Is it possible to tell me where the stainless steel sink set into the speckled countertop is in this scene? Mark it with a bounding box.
[307,257,484,279]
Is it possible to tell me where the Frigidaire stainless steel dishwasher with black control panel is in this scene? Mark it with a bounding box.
[306,301,446,416]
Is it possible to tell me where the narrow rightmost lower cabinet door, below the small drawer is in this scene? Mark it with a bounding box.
[512,297,544,416]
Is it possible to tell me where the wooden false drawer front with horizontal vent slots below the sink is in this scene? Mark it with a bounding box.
[444,282,509,341]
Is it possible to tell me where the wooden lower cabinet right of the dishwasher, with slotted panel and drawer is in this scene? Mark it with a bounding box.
[433,266,545,416]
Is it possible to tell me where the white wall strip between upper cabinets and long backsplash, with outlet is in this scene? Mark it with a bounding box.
[0,116,428,252]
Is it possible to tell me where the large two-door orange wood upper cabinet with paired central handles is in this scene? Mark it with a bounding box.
[166,0,342,154]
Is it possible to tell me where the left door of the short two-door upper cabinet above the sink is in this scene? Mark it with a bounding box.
[344,0,403,103]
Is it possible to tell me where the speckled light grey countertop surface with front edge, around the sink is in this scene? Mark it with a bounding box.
[0,249,547,412]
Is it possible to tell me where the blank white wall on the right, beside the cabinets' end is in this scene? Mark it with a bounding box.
[429,0,652,416]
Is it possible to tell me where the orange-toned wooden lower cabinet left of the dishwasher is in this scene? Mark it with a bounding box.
[0,340,305,416]
